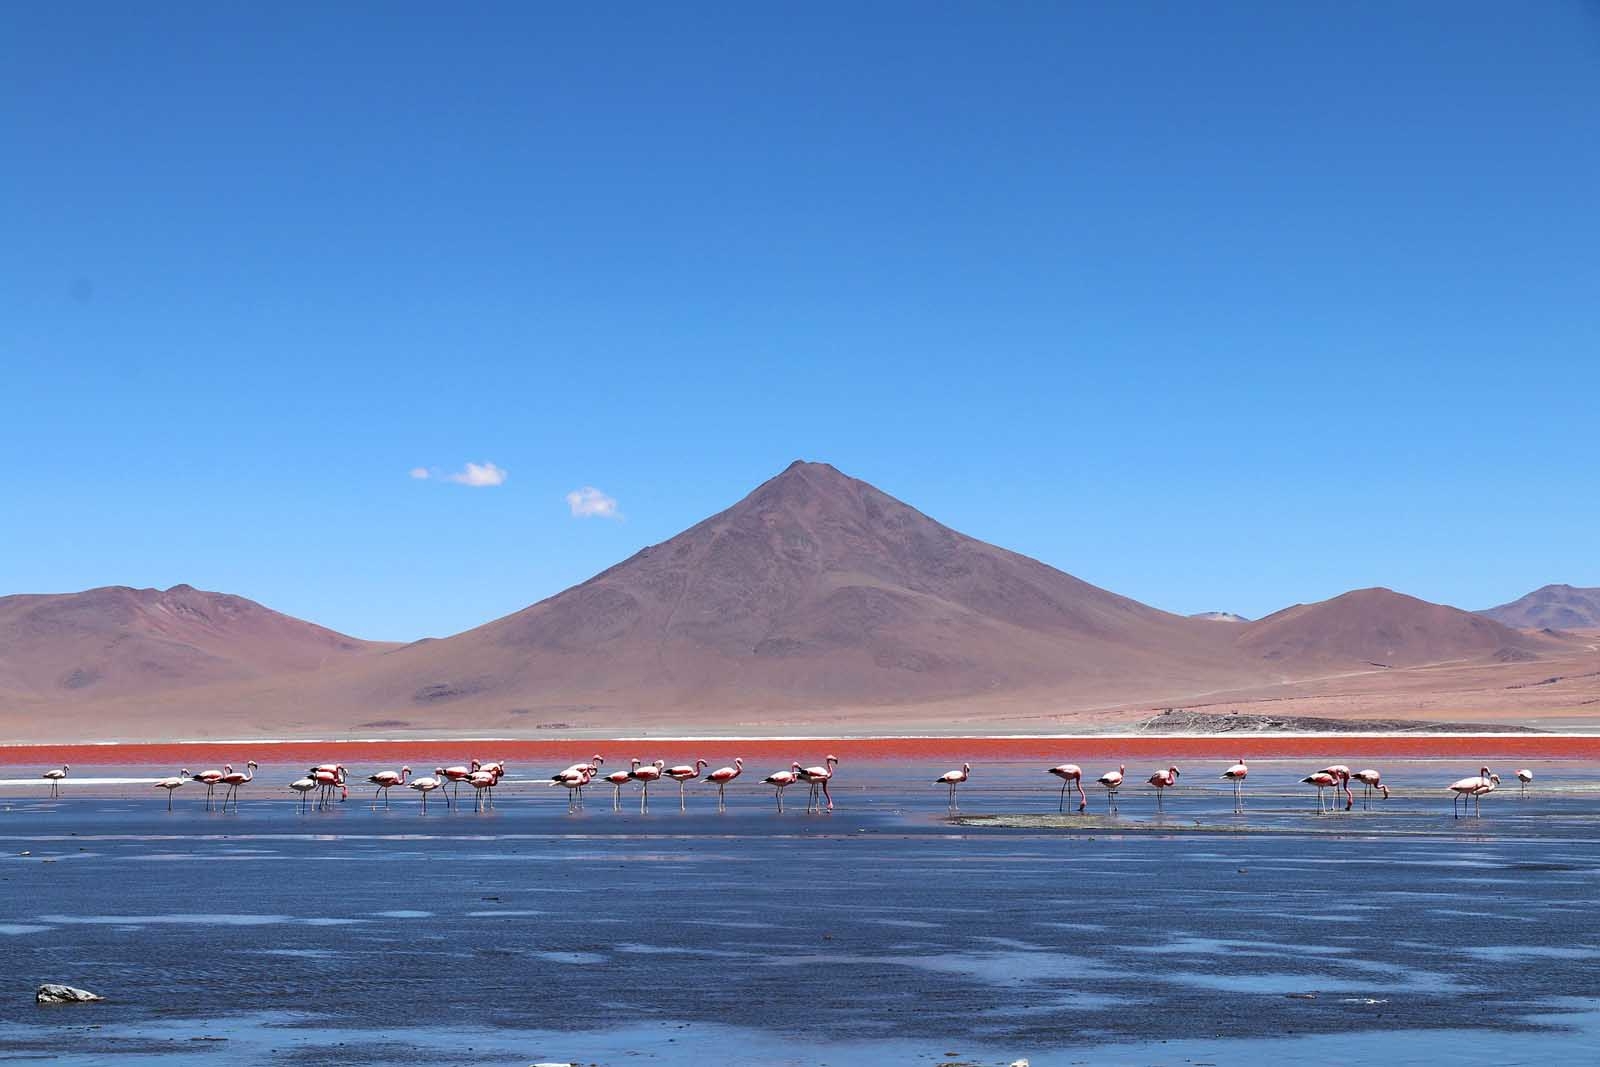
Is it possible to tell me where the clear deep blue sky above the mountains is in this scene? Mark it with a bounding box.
[0,0,1600,640]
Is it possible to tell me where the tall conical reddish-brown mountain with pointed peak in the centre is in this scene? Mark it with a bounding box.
[302,462,1235,721]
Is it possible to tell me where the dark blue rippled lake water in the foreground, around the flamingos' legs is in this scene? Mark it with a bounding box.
[0,757,1600,1067]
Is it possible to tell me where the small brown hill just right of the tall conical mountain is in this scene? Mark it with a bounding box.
[1238,589,1552,677]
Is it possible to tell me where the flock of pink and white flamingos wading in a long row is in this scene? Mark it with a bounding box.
[28,753,1534,819]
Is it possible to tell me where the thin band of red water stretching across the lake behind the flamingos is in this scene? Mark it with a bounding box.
[0,734,1600,768]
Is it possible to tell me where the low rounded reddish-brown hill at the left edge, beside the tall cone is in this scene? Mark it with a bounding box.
[0,585,382,702]
